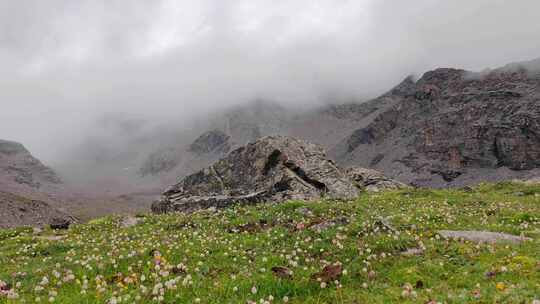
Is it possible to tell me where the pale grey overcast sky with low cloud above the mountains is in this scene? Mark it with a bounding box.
[0,0,540,160]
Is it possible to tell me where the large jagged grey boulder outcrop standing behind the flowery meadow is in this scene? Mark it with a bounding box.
[152,136,359,213]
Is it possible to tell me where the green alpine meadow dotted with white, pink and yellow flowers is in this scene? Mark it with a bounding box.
[0,183,540,303]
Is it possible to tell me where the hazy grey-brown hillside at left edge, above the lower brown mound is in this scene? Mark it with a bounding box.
[0,140,61,189]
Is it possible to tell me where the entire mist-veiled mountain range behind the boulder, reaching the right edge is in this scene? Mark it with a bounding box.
[48,59,540,195]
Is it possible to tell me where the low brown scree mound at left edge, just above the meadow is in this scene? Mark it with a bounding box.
[0,191,74,228]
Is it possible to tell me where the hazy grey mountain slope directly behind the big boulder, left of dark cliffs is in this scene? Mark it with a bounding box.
[140,101,389,188]
